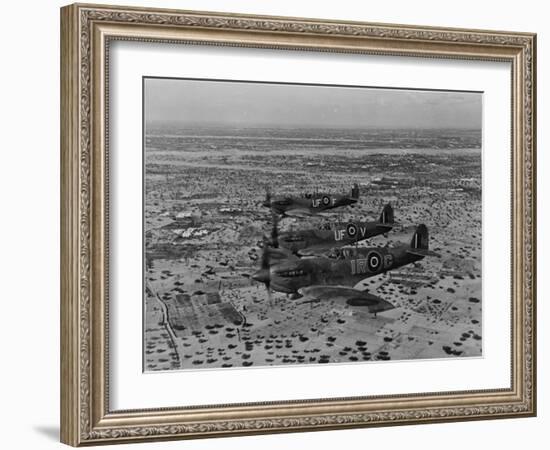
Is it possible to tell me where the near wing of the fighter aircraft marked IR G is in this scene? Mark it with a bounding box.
[298,285,394,313]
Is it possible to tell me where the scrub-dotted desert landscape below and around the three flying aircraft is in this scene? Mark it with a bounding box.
[143,123,482,371]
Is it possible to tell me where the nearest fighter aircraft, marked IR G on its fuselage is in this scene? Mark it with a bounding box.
[252,224,439,317]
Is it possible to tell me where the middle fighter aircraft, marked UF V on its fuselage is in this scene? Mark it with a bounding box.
[270,204,395,256]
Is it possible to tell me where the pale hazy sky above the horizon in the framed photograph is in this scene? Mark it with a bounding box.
[145,78,482,129]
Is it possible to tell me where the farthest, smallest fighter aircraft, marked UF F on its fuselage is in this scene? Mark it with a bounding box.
[262,184,359,218]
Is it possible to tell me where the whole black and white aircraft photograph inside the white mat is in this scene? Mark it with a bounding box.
[143,77,483,371]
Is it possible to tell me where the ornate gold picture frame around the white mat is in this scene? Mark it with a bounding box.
[61,4,536,446]
